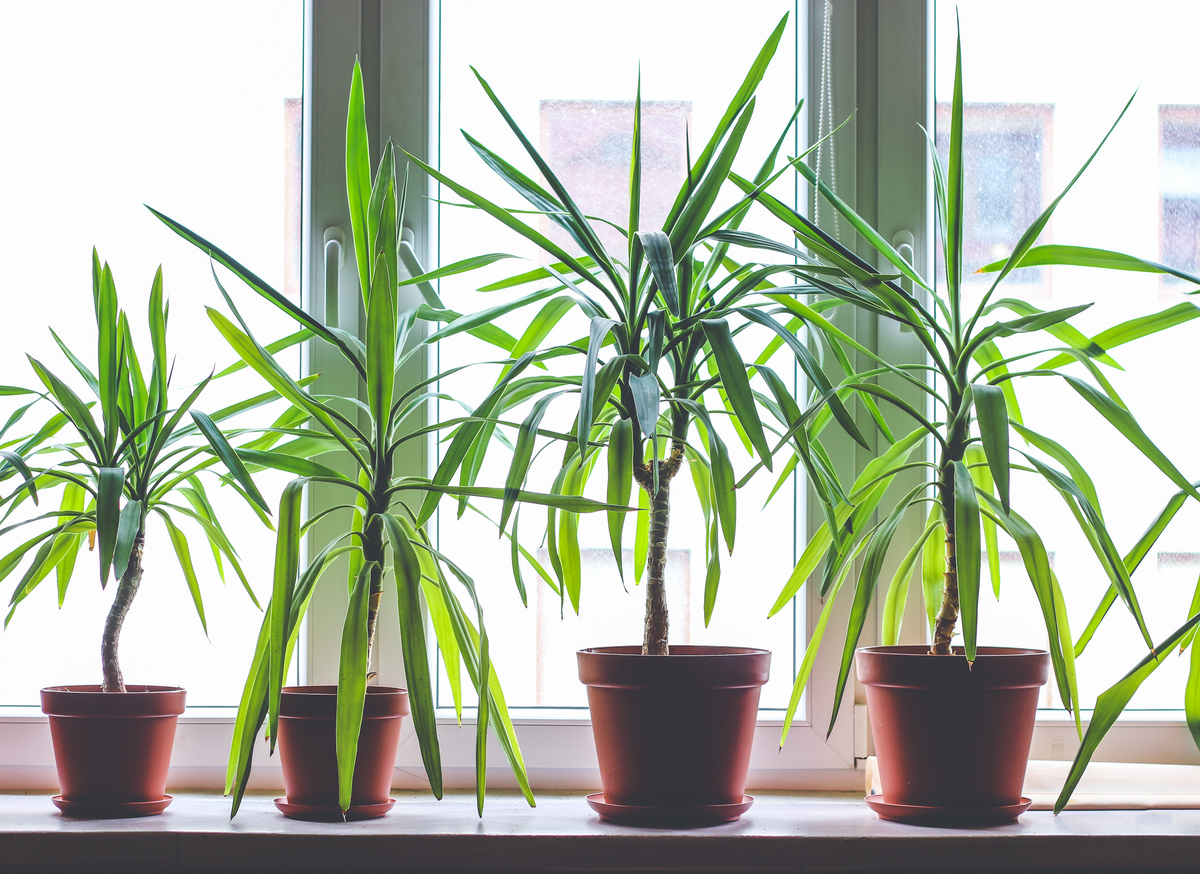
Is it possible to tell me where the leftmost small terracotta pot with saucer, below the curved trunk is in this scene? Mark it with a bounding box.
[42,686,187,819]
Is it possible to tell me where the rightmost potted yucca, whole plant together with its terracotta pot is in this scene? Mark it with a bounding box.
[753,23,1200,822]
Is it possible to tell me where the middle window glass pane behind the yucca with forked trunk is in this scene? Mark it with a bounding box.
[434,0,804,708]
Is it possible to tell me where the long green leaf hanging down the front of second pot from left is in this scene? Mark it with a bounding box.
[336,559,379,813]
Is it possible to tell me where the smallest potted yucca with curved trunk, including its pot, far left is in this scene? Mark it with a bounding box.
[0,251,280,816]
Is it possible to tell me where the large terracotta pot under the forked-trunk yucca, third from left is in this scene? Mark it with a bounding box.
[577,646,770,825]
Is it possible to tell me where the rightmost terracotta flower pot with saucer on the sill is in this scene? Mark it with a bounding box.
[857,646,1050,822]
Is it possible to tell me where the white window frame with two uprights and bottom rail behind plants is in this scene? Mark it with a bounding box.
[0,0,1200,791]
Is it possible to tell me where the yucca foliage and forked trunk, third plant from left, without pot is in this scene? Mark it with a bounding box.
[400,16,865,654]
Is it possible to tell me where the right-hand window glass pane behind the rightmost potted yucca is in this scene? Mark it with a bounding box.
[936,0,1200,710]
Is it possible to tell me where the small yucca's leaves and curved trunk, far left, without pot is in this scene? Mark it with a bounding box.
[0,250,278,693]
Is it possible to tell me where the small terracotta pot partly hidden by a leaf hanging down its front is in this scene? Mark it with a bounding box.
[275,686,409,820]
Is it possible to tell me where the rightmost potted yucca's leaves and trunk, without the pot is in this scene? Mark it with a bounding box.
[753,23,1200,809]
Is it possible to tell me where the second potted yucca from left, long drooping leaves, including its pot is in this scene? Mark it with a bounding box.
[151,62,628,819]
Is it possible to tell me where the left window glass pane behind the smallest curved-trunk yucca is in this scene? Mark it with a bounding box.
[0,0,304,706]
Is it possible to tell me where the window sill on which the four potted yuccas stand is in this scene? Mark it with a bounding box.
[7,794,1200,872]
